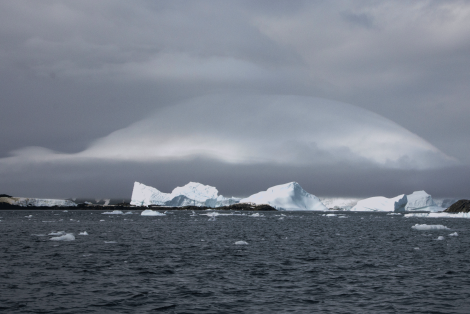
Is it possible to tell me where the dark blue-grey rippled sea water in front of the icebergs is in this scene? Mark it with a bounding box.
[0,211,470,313]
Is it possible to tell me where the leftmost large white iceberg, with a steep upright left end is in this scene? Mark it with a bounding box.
[131,182,239,207]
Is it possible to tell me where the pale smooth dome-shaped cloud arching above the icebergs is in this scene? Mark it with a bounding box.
[66,95,456,169]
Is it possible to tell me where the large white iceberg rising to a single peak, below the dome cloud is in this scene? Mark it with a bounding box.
[240,182,328,210]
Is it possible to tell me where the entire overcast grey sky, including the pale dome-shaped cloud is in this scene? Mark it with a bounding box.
[0,0,470,199]
